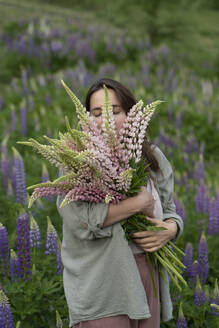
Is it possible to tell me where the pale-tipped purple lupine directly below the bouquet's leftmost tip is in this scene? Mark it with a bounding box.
[12,147,27,205]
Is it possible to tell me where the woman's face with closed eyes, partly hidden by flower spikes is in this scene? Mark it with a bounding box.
[90,89,126,135]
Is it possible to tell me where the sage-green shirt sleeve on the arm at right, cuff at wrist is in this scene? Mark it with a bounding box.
[153,147,183,241]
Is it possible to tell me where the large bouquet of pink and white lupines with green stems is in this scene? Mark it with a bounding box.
[18,81,186,290]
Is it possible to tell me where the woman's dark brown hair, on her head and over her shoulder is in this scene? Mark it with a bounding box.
[85,78,159,172]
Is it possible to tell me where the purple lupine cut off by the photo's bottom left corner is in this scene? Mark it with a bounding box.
[0,289,14,328]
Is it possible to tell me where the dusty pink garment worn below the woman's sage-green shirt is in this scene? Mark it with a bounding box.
[72,253,160,328]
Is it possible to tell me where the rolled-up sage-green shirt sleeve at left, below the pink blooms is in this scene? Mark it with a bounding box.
[56,196,112,240]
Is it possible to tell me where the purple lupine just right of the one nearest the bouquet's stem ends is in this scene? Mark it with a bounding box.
[198,232,209,283]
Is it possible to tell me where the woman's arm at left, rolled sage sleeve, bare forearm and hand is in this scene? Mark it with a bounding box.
[56,187,154,240]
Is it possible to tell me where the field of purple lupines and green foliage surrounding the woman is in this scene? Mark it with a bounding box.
[0,18,219,328]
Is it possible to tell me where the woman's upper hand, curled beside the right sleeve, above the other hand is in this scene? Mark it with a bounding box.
[135,187,155,218]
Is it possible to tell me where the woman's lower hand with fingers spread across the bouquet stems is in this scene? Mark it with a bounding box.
[132,218,177,253]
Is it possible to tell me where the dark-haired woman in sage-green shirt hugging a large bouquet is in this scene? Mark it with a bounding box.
[57,79,183,328]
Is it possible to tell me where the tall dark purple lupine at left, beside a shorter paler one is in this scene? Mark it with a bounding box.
[17,212,31,279]
